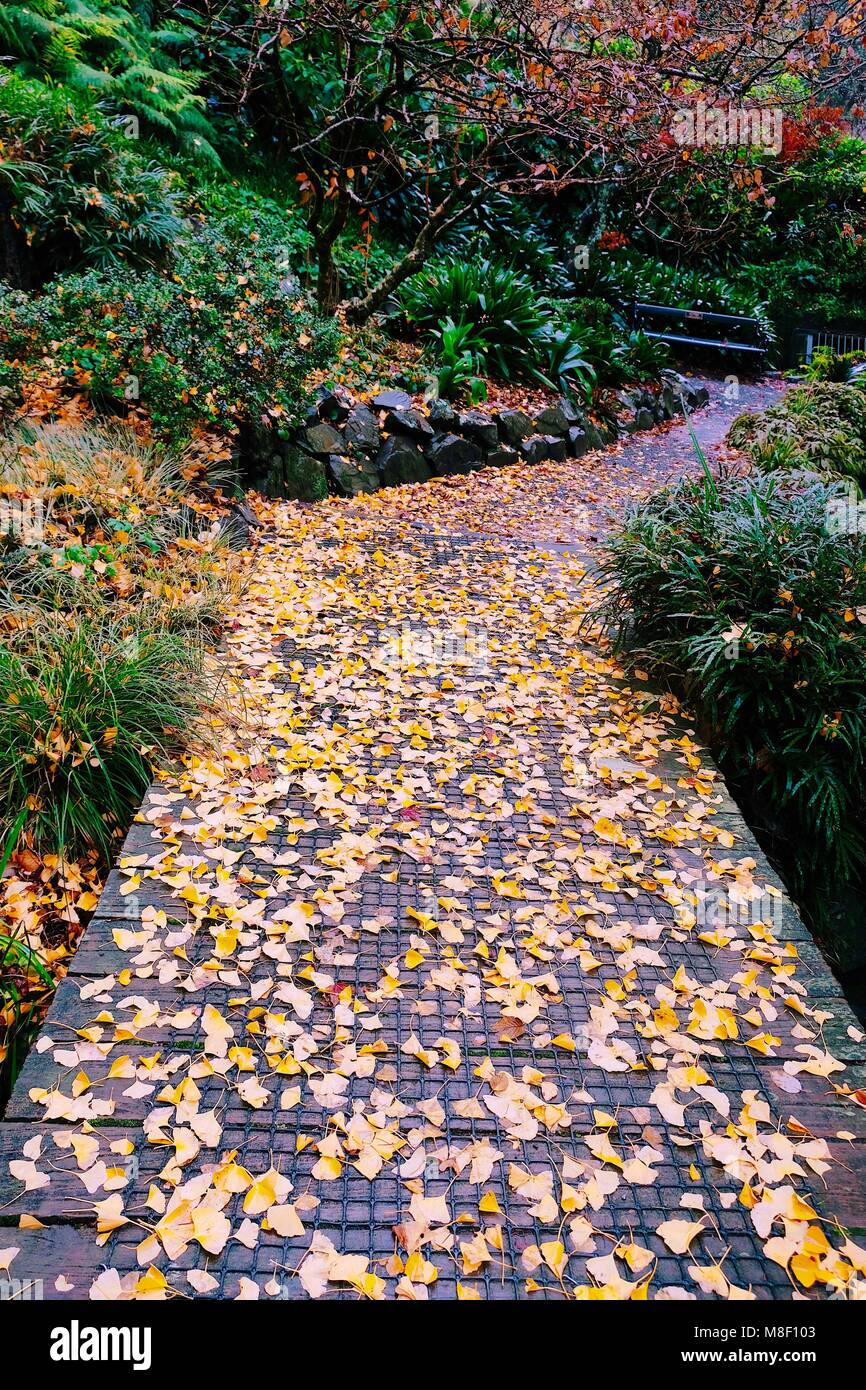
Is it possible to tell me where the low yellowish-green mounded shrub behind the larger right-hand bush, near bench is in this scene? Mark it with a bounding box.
[727,377,866,478]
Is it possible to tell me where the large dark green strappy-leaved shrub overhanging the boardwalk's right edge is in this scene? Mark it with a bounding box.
[603,473,866,883]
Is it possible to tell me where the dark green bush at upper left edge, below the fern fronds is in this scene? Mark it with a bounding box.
[0,75,182,288]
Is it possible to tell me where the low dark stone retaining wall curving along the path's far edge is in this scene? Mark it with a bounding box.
[245,371,709,498]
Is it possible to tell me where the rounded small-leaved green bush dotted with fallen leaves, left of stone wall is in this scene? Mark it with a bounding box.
[0,225,339,439]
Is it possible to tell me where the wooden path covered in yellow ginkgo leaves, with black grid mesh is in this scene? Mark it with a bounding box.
[0,375,866,1300]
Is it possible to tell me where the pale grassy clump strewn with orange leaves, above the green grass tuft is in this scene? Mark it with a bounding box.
[0,424,235,633]
